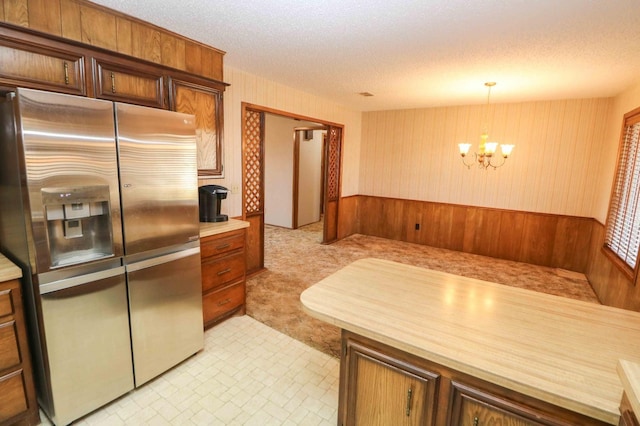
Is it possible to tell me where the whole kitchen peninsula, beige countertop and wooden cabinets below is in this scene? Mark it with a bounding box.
[300,259,640,425]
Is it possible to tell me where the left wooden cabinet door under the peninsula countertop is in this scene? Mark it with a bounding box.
[346,341,438,426]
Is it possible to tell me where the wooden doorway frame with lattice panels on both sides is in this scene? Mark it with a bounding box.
[240,102,344,274]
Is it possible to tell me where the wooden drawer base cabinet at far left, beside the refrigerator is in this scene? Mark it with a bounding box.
[0,280,40,425]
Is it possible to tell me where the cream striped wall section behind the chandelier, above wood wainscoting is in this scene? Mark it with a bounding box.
[359,98,617,216]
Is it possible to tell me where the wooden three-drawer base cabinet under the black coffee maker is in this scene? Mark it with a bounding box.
[200,229,246,328]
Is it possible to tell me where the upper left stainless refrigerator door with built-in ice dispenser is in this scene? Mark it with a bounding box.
[13,89,123,274]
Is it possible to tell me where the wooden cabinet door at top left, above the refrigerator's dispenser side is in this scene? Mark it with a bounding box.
[0,38,85,95]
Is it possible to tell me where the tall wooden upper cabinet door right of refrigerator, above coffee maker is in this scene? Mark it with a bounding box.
[169,78,223,177]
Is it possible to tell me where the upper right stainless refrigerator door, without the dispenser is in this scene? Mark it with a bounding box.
[115,103,200,256]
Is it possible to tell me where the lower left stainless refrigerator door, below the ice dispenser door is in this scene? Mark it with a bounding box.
[41,267,133,425]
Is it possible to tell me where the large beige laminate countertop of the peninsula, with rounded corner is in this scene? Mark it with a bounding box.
[300,259,640,424]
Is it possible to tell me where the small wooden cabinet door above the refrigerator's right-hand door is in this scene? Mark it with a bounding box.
[93,58,165,108]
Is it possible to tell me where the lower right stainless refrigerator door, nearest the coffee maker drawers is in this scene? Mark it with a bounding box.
[126,247,204,387]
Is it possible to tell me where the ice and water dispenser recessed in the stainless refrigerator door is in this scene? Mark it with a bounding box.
[42,185,114,268]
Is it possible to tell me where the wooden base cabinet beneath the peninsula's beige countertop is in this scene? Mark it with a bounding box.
[338,330,608,426]
